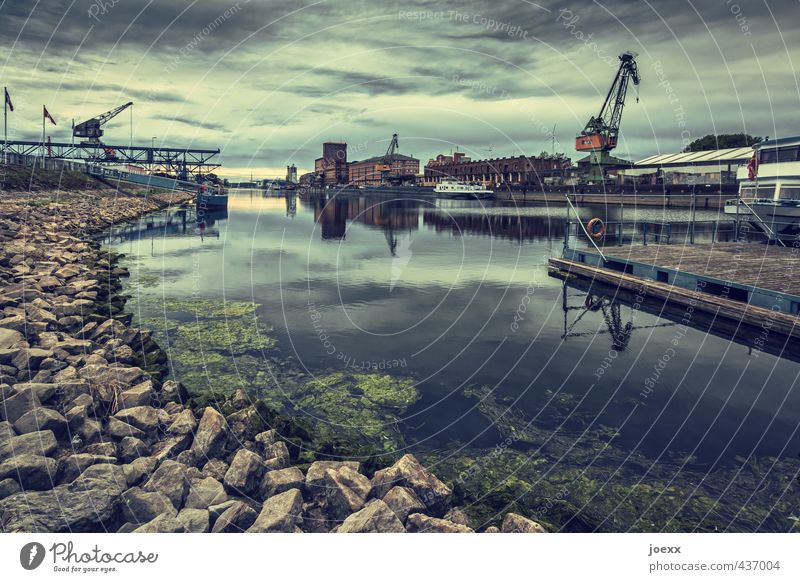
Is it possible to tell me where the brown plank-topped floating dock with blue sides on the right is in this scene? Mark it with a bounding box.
[550,242,800,338]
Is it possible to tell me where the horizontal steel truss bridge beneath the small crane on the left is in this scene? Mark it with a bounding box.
[0,141,220,178]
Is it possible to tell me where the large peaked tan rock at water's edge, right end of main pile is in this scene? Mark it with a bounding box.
[372,454,453,515]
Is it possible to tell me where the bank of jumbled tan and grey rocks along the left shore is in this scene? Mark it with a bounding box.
[0,188,545,533]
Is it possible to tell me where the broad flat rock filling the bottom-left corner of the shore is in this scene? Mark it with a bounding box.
[0,465,127,533]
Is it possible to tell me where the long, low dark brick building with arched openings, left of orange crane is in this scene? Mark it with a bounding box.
[425,152,572,185]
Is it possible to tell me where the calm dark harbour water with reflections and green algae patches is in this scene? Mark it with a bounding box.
[108,193,800,531]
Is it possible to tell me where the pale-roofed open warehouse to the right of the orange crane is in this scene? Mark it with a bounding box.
[618,147,753,186]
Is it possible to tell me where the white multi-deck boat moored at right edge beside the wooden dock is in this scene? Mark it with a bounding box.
[725,136,800,240]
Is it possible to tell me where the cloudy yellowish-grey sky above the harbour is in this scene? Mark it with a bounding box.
[0,0,800,177]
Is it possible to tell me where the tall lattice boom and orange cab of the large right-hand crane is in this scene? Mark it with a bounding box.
[575,52,641,152]
